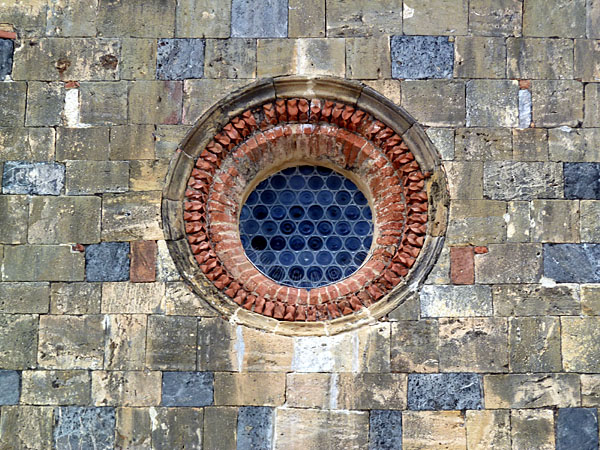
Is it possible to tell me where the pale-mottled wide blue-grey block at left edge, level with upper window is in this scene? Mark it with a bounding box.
[2,161,65,195]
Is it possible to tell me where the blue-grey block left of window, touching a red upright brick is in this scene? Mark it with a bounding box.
[85,242,129,281]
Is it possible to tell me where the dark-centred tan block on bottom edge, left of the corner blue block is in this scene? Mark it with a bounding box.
[510,409,555,450]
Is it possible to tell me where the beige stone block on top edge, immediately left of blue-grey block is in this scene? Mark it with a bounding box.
[175,0,231,38]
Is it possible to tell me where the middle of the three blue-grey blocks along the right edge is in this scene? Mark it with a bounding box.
[544,244,600,283]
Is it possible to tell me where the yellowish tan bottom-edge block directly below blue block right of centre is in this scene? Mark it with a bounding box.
[402,411,467,450]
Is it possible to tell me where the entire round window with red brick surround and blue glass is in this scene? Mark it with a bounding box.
[163,77,447,334]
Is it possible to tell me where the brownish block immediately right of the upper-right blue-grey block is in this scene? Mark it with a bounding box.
[454,36,506,78]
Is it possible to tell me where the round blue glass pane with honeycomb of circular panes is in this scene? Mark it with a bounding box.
[240,165,373,289]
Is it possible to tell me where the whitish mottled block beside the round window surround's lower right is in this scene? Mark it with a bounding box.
[421,285,492,317]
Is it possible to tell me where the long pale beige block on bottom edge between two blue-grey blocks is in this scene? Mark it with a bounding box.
[274,408,369,450]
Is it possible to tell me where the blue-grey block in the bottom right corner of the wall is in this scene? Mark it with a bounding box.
[556,408,598,450]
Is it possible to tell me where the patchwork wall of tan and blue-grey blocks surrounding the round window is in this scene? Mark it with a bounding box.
[0,0,600,450]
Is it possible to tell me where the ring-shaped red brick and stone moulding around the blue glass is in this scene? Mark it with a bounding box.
[163,77,448,335]
